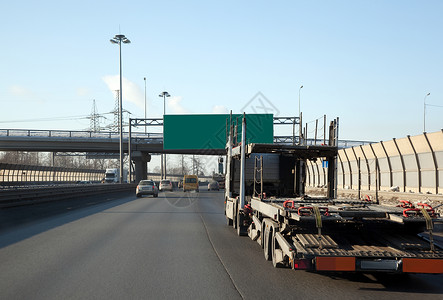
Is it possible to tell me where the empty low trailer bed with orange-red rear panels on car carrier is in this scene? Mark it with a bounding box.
[248,198,443,273]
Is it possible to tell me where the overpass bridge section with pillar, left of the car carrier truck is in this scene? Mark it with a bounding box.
[0,125,226,181]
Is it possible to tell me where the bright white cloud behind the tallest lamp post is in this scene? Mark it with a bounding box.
[102,75,145,109]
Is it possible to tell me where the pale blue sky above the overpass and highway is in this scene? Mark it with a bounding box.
[0,0,443,141]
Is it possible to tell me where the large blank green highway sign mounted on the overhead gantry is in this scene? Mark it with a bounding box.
[163,114,274,150]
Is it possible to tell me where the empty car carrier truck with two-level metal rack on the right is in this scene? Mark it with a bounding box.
[225,113,443,274]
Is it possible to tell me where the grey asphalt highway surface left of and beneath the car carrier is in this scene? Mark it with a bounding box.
[0,191,443,299]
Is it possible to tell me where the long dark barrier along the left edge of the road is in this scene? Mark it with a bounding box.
[0,184,136,208]
